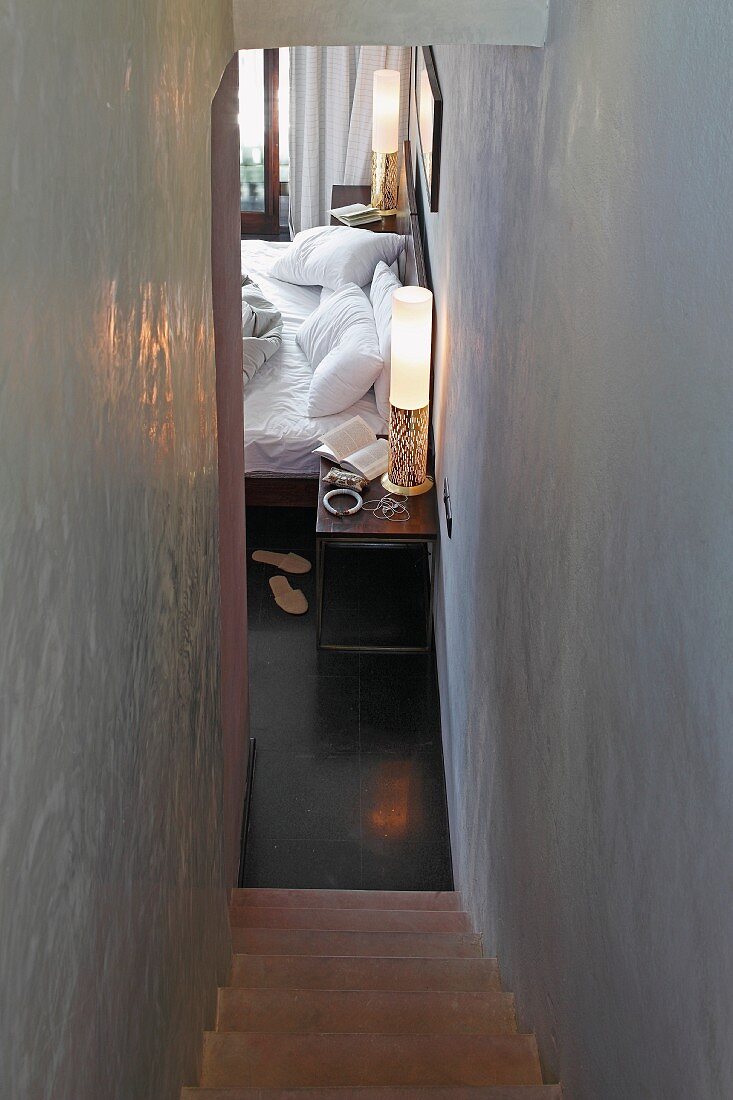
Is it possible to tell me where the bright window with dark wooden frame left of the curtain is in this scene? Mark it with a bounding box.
[239,48,289,234]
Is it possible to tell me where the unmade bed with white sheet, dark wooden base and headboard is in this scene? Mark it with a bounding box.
[241,143,427,506]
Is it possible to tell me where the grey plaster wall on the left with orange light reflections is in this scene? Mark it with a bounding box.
[0,0,232,1100]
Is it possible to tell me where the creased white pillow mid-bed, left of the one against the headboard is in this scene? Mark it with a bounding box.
[295,284,384,416]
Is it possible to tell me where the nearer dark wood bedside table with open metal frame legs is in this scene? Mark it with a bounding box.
[316,459,438,653]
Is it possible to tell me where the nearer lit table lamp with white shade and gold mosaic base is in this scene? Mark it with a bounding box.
[382,286,433,496]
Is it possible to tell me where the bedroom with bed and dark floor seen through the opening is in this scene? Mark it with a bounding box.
[238,40,452,890]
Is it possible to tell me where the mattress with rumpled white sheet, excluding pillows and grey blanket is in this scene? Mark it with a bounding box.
[242,241,386,477]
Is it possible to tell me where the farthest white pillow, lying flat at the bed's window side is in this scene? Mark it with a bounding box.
[270,226,405,290]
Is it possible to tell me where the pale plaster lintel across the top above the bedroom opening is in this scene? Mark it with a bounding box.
[233,0,548,50]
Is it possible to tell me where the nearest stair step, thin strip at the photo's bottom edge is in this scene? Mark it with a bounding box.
[180,1085,562,1100]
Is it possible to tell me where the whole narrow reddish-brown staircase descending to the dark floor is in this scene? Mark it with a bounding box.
[182,890,561,1100]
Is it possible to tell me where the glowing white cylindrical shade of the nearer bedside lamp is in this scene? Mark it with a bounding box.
[390,286,433,409]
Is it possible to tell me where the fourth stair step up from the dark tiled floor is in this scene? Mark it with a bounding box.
[230,955,501,992]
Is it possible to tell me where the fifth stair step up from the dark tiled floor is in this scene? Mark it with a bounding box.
[217,987,516,1035]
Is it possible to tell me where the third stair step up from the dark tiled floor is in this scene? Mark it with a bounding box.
[231,927,481,958]
